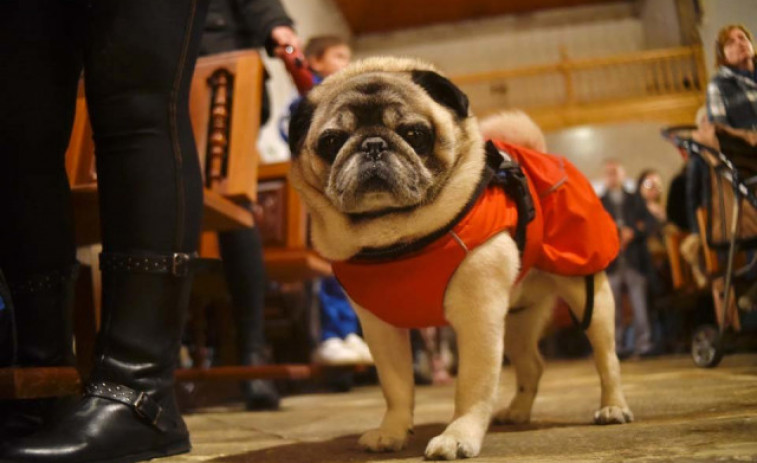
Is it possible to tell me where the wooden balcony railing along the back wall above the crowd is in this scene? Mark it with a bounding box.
[452,46,706,114]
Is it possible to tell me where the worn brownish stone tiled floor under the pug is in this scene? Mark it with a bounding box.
[165,354,757,463]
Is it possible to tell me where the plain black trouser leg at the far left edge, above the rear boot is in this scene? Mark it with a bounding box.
[0,0,83,280]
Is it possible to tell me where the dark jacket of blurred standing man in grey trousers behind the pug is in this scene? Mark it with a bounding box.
[601,191,651,275]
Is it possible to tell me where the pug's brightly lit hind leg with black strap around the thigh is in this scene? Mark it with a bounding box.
[553,272,633,424]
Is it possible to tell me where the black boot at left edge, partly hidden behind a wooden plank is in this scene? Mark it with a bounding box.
[0,264,79,440]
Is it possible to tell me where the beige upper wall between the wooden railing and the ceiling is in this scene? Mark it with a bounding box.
[353,2,644,74]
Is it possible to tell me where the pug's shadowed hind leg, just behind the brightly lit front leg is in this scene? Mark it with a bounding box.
[494,271,555,424]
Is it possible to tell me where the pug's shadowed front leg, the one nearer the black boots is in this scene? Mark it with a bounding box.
[350,301,414,452]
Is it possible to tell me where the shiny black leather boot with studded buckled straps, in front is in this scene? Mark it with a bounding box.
[0,253,191,463]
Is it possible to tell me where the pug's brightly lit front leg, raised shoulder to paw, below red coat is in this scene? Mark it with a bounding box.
[425,233,518,460]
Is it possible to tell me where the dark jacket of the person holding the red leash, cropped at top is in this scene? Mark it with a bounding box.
[200,0,294,124]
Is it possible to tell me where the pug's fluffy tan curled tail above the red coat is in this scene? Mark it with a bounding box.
[479,109,547,153]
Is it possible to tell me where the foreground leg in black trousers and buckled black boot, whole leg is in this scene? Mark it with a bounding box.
[0,0,207,463]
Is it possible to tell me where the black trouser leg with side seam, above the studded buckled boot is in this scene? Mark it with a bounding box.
[85,0,208,254]
